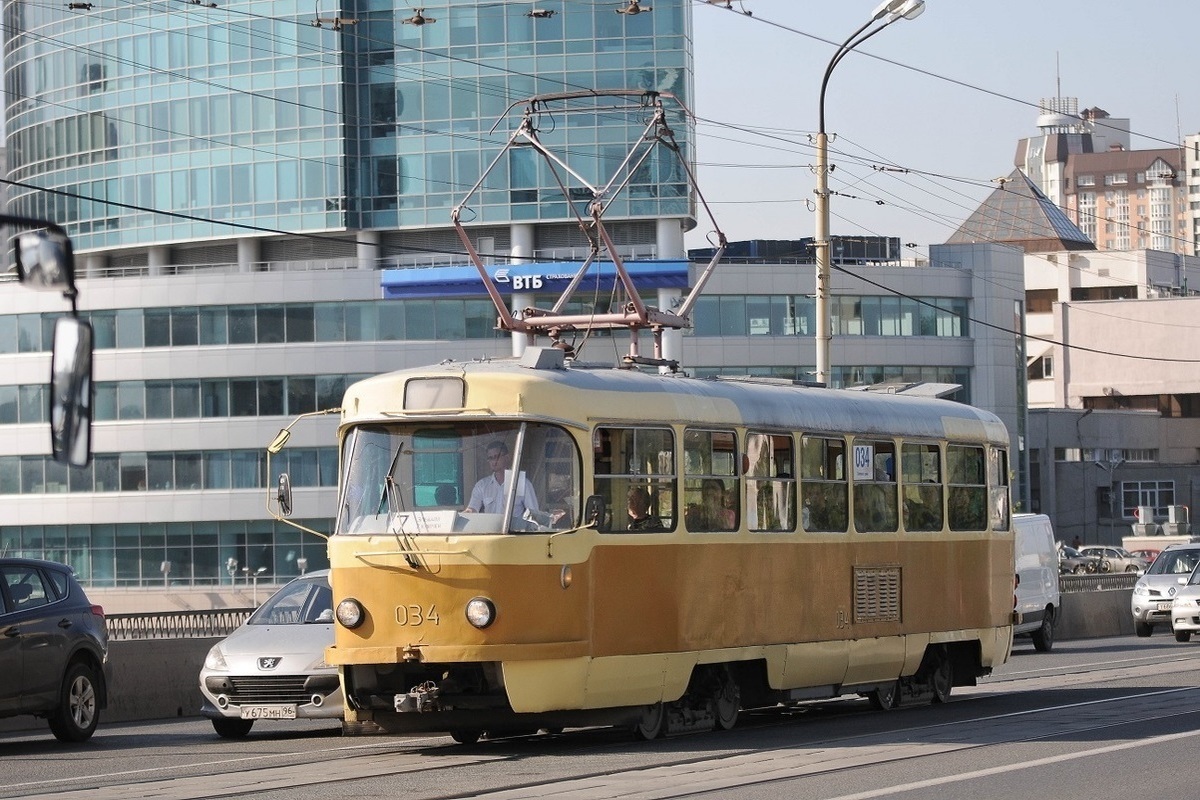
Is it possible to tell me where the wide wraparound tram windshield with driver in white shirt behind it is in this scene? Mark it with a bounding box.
[336,422,581,535]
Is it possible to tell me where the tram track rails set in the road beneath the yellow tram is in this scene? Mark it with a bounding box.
[0,651,1200,800]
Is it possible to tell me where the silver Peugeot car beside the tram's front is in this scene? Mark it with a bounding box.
[200,570,343,739]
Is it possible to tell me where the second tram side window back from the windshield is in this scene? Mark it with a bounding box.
[683,428,742,531]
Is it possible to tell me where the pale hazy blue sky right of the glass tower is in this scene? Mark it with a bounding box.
[685,0,1200,255]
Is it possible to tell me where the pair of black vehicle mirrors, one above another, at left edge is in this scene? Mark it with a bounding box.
[0,215,92,467]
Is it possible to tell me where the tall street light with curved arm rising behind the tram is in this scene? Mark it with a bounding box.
[816,0,925,386]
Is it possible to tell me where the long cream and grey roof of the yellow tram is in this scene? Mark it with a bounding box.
[347,359,1008,445]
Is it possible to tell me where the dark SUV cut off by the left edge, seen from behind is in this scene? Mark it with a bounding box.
[0,558,108,741]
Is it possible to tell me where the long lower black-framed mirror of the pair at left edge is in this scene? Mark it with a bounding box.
[50,317,92,467]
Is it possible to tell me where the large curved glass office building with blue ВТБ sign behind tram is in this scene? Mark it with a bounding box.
[0,0,1020,590]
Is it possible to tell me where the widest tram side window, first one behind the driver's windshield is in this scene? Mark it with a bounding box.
[592,427,676,533]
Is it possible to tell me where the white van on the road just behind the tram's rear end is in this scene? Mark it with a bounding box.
[1013,513,1062,652]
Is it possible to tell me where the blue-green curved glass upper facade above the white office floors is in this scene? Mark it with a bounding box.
[5,0,692,252]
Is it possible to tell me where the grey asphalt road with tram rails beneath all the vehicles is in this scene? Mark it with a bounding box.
[0,636,1200,800]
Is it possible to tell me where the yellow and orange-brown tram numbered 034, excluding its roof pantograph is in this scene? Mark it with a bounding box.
[312,348,1013,741]
